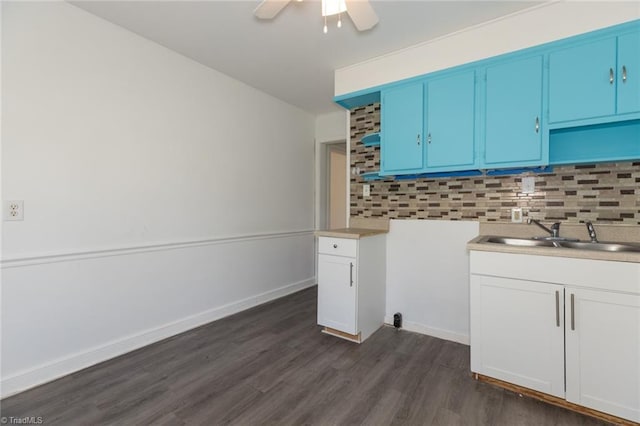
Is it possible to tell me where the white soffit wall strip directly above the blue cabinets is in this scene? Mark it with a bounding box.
[335,0,640,95]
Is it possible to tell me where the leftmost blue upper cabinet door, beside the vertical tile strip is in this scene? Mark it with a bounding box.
[380,83,424,175]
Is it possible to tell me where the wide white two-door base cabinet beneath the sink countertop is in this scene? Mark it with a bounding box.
[470,250,640,422]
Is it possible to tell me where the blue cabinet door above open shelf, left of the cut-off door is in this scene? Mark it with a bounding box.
[549,37,616,123]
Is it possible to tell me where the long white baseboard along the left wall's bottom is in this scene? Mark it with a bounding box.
[0,277,316,398]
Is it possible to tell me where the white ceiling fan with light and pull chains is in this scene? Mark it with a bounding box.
[253,0,378,33]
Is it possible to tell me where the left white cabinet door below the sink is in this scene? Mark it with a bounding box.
[471,275,564,398]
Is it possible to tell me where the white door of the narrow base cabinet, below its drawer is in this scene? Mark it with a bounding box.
[318,254,358,334]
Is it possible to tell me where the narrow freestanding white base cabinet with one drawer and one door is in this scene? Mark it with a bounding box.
[318,234,386,342]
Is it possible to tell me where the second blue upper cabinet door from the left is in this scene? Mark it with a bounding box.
[425,71,476,171]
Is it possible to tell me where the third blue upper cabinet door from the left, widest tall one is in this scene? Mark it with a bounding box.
[484,56,546,167]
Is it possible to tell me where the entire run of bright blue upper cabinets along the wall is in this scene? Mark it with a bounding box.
[335,20,640,179]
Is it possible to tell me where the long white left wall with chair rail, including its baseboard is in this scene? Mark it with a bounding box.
[1,2,315,395]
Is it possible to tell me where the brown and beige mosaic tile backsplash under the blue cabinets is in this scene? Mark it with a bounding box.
[350,103,640,225]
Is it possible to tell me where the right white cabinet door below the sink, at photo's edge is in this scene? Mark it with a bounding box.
[565,287,640,422]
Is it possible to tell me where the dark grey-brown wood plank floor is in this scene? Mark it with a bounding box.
[2,287,604,426]
